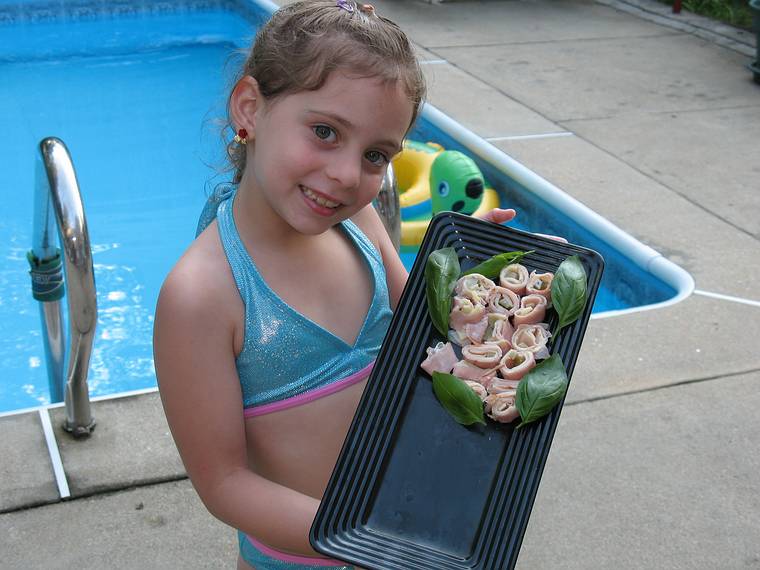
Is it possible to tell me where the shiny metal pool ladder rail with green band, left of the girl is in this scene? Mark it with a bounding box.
[27,137,97,438]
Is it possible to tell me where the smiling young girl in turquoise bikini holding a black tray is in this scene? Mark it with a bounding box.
[154,0,514,570]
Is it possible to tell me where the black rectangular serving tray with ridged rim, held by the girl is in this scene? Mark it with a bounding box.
[310,212,604,570]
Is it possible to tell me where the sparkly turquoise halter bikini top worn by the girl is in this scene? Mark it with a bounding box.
[198,186,392,408]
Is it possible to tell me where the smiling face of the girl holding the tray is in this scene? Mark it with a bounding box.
[243,72,413,235]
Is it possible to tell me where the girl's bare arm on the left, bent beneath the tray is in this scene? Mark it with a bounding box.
[154,262,326,556]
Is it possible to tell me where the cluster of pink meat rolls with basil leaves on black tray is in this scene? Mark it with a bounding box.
[421,248,587,427]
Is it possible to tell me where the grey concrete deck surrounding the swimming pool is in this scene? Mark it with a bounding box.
[0,0,760,570]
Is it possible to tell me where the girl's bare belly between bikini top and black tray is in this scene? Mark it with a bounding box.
[240,380,366,499]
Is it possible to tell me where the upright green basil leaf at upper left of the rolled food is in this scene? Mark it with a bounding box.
[425,247,459,338]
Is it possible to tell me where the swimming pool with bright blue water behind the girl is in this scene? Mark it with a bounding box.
[0,0,692,412]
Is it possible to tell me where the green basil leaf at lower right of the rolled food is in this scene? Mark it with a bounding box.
[515,354,568,429]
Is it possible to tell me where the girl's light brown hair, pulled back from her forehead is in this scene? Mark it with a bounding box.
[225,0,425,183]
